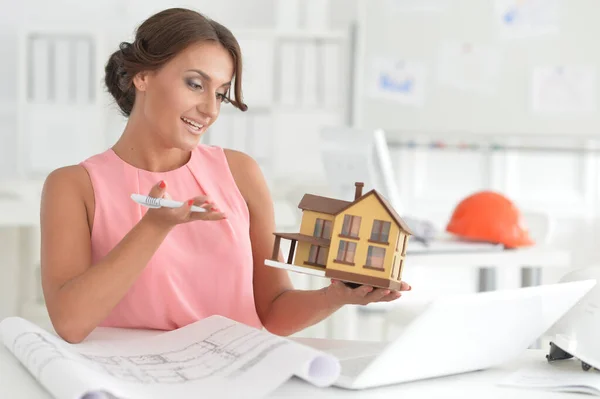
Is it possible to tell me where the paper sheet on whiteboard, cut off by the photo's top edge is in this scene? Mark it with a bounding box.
[494,0,560,39]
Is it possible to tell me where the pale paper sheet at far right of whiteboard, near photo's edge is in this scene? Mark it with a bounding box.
[532,66,596,115]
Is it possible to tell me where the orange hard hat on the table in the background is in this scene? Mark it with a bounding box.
[446,191,534,248]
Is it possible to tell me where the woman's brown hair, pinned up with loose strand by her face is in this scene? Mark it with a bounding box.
[104,8,248,116]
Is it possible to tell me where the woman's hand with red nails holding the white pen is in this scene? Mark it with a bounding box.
[142,181,227,229]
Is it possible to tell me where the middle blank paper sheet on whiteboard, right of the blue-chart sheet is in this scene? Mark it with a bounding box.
[437,41,500,94]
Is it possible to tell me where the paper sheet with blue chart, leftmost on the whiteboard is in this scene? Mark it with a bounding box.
[367,57,427,107]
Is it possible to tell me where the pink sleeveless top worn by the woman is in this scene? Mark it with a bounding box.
[81,144,262,330]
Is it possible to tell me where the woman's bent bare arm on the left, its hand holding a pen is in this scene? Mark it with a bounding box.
[40,166,219,343]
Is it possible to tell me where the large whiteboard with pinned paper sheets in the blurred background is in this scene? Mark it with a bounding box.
[353,0,600,135]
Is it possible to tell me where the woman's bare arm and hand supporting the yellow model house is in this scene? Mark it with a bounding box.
[226,150,408,335]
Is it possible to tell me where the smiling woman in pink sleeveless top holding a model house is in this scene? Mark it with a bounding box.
[41,8,409,343]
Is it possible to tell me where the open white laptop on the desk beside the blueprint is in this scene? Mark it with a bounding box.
[333,280,596,389]
